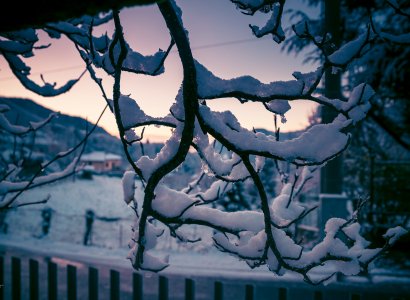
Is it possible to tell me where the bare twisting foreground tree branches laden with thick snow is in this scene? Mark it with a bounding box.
[1,0,408,284]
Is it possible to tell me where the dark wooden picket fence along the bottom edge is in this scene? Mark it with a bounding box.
[0,256,405,300]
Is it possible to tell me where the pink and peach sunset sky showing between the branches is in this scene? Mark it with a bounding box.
[0,0,320,141]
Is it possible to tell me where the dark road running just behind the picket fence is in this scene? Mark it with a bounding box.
[0,246,410,300]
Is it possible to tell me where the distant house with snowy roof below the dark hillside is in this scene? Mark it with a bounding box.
[80,151,122,172]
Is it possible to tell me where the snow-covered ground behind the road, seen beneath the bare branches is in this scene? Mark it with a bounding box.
[0,176,410,283]
